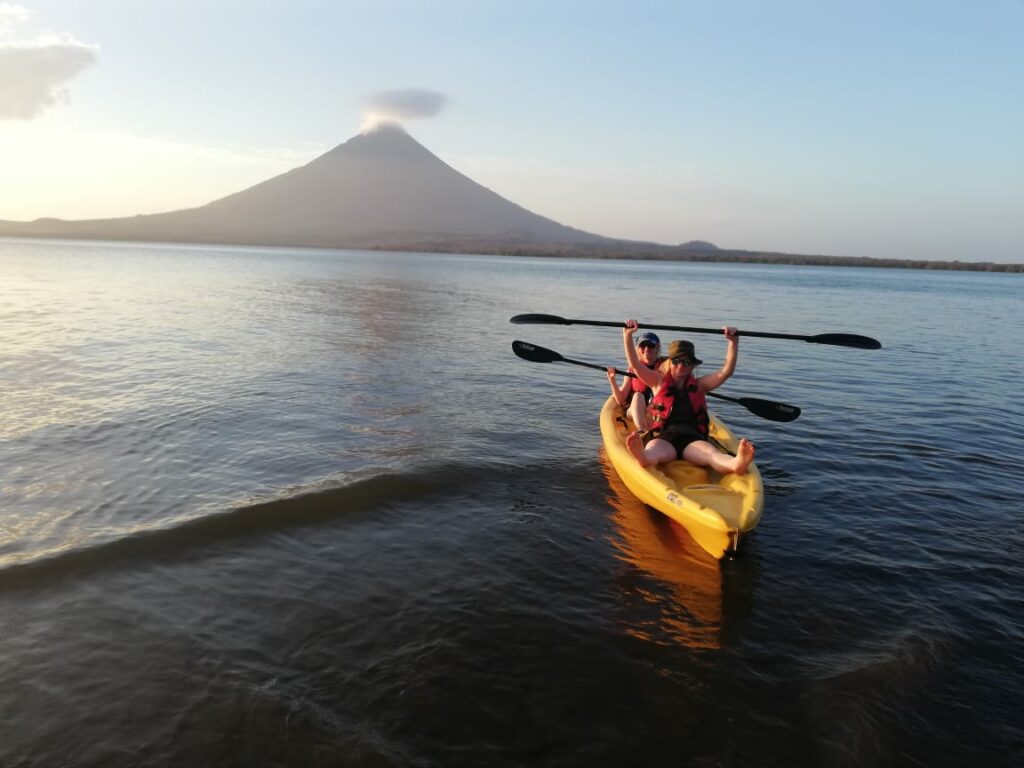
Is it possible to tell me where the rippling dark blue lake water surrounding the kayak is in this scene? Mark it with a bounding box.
[0,241,1024,767]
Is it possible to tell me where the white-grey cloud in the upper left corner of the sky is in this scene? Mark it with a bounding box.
[0,3,99,120]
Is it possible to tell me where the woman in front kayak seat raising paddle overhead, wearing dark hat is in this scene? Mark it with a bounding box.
[623,319,754,475]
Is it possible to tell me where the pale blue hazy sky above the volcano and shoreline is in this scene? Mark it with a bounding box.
[0,0,1024,261]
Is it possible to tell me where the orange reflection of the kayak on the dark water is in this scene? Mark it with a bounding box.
[601,450,722,649]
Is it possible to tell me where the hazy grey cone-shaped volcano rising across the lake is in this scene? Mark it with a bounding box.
[0,125,621,250]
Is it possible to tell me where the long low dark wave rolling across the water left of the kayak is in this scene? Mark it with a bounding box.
[0,462,586,591]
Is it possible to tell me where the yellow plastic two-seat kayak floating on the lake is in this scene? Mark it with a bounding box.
[601,397,765,558]
